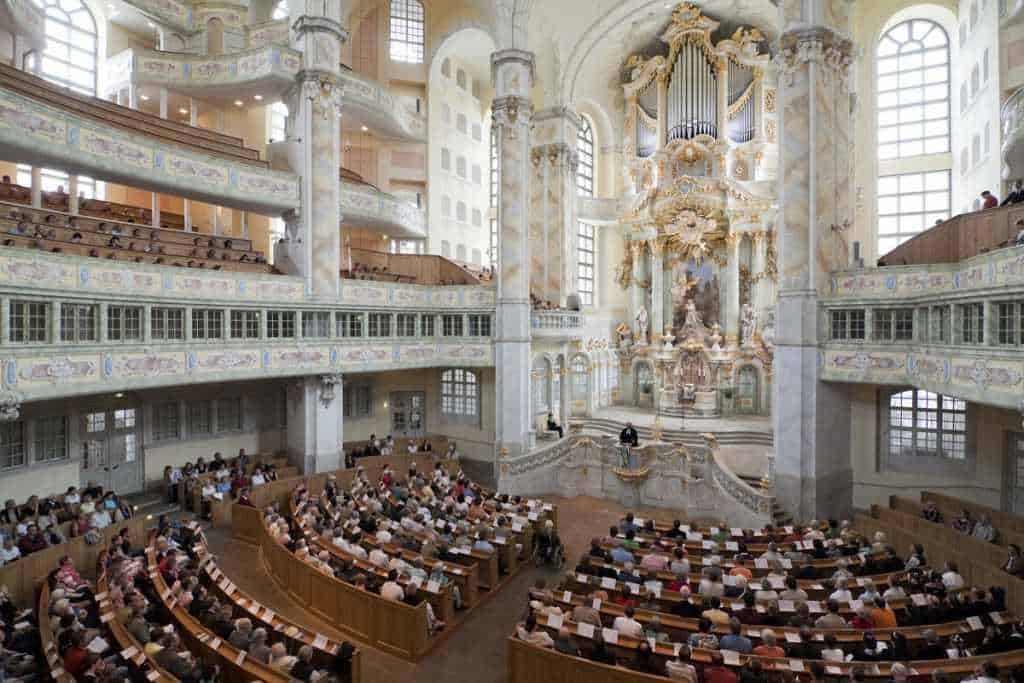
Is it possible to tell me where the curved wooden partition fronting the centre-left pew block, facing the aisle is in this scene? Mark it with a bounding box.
[260,525,430,659]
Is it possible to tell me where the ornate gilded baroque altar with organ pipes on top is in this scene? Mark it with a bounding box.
[615,3,778,417]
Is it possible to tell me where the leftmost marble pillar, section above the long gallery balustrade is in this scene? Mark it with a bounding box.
[285,0,348,299]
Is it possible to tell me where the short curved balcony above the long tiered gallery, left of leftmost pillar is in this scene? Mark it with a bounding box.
[106,44,302,102]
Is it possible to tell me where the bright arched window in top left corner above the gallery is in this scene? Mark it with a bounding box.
[38,0,98,95]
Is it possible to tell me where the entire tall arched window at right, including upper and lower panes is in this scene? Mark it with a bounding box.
[876,18,952,255]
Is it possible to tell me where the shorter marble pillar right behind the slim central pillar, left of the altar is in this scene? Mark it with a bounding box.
[529,106,580,305]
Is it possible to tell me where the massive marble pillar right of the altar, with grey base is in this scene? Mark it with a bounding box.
[773,0,854,519]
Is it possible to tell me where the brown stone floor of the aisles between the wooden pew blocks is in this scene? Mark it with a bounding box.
[207,497,704,683]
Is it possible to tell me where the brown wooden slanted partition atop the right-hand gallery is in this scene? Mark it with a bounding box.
[882,204,1024,265]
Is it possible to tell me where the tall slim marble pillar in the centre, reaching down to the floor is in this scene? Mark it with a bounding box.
[490,49,536,466]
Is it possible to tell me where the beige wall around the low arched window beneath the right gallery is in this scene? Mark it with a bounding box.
[849,386,1021,508]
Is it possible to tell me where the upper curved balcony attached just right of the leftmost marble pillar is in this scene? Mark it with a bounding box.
[339,66,427,142]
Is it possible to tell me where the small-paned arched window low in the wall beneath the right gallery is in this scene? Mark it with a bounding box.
[889,389,967,461]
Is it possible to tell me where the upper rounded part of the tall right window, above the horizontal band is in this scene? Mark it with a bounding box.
[877,19,949,160]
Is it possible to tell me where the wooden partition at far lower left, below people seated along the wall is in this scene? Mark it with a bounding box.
[0,517,145,607]
